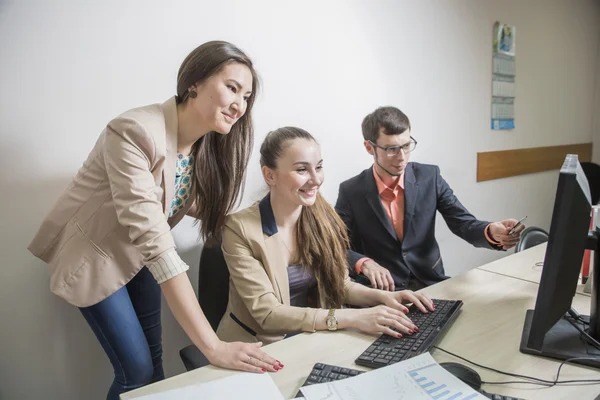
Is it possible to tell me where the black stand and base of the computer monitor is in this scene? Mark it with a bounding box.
[520,230,600,368]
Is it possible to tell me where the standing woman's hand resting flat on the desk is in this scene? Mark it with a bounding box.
[205,341,283,373]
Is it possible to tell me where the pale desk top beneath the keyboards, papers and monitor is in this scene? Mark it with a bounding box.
[121,253,600,400]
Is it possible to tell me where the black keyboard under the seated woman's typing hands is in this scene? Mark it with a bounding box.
[355,299,463,368]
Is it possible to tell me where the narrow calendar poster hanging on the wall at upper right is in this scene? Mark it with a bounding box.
[492,22,517,130]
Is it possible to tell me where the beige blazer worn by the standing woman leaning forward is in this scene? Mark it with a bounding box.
[28,97,194,307]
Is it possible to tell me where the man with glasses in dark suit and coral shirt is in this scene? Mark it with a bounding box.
[335,107,524,290]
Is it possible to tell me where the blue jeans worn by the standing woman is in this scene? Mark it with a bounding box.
[79,267,165,400]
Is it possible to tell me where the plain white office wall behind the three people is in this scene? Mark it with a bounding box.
[0,0,600,399]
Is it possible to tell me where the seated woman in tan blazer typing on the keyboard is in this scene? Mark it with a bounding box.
[217,127,433,344]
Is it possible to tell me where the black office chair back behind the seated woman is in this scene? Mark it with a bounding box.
[179,240,229,371]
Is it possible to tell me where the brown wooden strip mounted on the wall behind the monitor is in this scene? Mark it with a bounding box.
[477,143,592,182]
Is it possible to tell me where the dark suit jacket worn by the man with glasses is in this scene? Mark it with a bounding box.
[335,162,498,289]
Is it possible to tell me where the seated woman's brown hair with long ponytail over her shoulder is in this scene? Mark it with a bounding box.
[260,127,349,308]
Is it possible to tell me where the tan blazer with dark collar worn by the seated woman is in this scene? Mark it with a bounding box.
[217,196,357,344]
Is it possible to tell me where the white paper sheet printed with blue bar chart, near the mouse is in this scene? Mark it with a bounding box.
[301,353,487,400]
